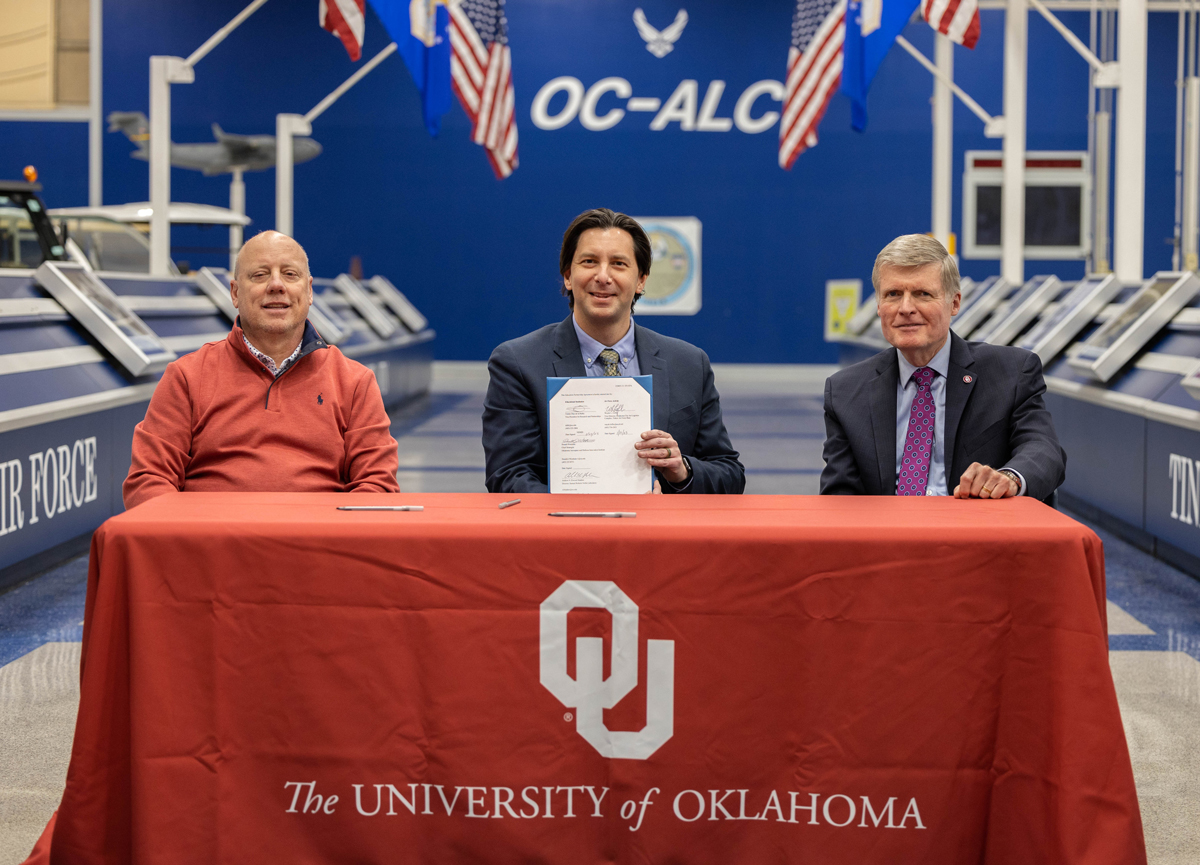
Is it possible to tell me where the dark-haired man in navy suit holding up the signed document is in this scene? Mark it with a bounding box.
[484,208,745,493]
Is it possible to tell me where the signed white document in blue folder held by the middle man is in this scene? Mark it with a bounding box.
[546,376,654,493]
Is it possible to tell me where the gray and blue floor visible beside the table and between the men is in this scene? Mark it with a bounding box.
[0,364,1200,865]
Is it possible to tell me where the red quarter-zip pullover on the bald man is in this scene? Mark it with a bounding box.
[122,325,400,507]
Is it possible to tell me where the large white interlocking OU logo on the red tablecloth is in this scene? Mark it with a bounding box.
[541,579,674,759]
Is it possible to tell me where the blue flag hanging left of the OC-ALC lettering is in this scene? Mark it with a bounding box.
[371,0,451,136]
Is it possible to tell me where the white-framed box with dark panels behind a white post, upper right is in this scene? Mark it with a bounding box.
[962,150,1092,260]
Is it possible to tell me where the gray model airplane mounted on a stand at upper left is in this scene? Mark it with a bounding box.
[108,112,322,175]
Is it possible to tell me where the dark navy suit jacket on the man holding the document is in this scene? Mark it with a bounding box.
[484,316,745,493]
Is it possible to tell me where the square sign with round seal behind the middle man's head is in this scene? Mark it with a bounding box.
[634,216,701,316]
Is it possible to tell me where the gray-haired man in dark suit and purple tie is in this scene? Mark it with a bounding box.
[821,234,1067,499]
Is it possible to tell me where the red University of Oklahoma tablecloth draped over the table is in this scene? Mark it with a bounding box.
[35,493,1145,865]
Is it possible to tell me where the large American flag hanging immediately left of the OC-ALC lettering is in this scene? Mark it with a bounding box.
[446,0,517,180]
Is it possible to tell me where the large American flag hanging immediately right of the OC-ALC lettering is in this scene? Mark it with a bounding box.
[779,0,846,168]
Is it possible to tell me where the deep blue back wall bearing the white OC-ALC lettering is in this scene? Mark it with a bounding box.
[0,0,1176,362]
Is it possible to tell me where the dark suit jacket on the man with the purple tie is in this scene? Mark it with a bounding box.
[821,331,1067,499]
